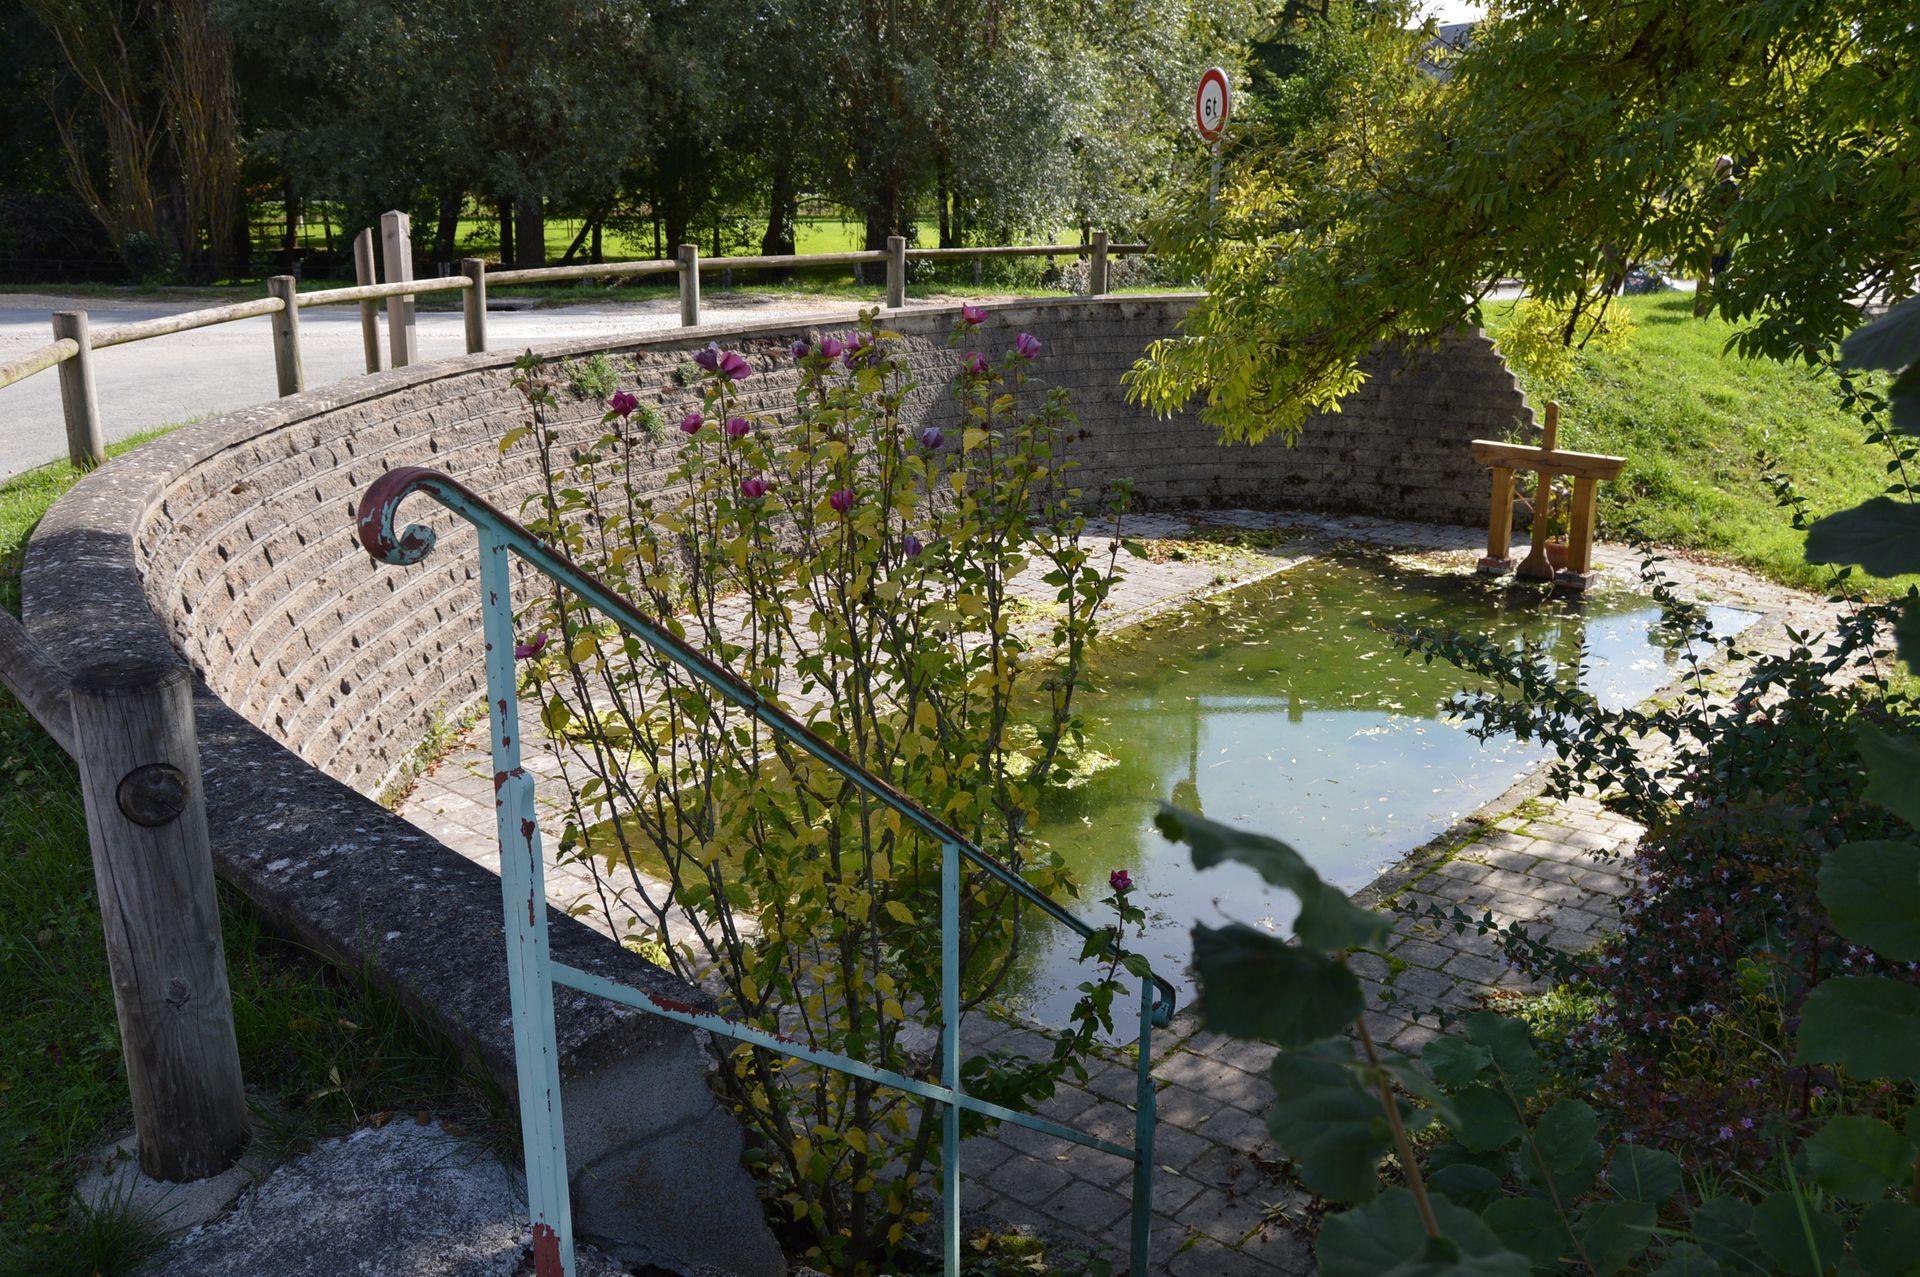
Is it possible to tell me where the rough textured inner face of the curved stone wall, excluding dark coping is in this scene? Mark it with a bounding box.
[105,298,1530,793]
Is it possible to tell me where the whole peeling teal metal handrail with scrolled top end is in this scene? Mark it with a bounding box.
[357,467,1175,1277]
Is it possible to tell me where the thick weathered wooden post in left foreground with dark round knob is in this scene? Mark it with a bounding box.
[71,657,250,1183]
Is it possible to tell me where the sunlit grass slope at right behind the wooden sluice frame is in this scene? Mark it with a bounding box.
[1488,294,1920,593]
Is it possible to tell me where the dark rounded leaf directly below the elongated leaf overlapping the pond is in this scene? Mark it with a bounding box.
[1192,922,1365,1047]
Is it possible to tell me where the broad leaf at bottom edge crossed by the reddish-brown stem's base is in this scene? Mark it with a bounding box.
[1315,1189,1528,1277]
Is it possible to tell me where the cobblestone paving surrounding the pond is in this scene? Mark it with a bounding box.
[399,511,1834,1277]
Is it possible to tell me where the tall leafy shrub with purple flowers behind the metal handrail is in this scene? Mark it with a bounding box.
[501,313,1144,1269]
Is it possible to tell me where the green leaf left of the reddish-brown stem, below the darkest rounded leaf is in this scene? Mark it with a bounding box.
[1267,1041,1392,1202]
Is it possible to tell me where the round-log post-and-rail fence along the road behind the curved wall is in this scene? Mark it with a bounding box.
[0,213,1150,469]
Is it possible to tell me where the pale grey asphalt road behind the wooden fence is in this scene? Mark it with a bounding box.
[0,294,858,478]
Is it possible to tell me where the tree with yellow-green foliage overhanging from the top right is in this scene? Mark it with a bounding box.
[1129,0,1920,440]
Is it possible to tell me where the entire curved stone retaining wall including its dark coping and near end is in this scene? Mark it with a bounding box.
[23,296,1532,1273]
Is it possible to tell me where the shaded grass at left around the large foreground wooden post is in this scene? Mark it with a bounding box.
[0,436,509,1277]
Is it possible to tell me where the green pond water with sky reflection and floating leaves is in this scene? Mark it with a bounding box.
[1010,555,1753,1037]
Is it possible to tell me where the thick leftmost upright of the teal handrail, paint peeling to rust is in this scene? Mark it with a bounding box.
[480,526,574,1277]
